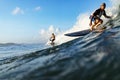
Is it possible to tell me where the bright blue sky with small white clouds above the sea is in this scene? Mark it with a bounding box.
[0,0,110,43]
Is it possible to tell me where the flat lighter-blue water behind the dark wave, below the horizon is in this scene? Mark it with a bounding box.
[0,43,48,60]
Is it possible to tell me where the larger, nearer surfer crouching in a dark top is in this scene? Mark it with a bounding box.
[89,3,111,31]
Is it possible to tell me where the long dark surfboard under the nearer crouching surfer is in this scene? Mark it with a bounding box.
[64,29,105,37]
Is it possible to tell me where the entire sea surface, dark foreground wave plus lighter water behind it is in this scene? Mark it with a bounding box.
[0,6,120,80]
